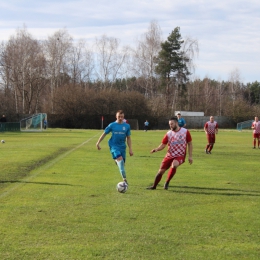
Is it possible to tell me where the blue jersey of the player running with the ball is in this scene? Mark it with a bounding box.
[105,122,131,151]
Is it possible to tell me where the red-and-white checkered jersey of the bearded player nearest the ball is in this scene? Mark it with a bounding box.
[162,127,192,158]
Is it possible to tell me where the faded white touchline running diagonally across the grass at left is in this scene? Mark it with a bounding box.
[0,133,100,199]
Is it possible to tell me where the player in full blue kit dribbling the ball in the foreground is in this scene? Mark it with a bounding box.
[96,110,133,183]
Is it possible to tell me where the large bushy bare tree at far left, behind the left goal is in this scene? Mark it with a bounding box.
[1,28,46,113]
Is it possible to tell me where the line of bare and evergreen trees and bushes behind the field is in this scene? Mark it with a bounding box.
[0,21,260,125]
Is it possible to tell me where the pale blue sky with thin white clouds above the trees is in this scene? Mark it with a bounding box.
[0,0,260,83]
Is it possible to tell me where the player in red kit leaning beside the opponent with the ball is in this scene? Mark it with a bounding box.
[147,117,193,190]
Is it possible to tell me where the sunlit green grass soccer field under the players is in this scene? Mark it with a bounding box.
[0,129,260,260]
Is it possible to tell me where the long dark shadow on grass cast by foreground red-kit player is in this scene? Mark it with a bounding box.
[165,185,260,197]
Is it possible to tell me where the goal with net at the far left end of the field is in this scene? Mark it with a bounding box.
[20,113,47,132]
